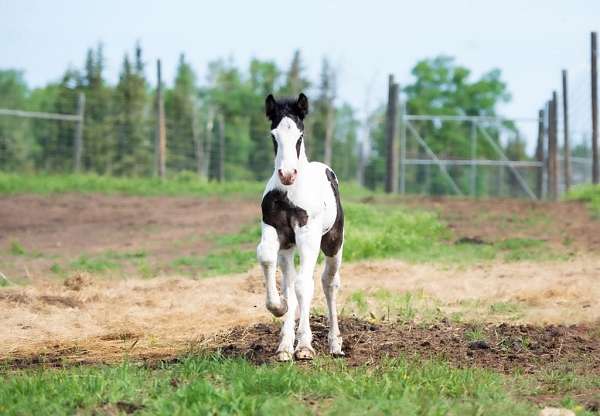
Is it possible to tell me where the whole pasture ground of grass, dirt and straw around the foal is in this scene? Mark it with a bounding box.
[0,175,600,415]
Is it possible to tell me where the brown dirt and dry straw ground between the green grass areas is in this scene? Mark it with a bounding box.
[0,195,600,371]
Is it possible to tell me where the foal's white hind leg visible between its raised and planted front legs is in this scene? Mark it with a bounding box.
[275,248,298,361]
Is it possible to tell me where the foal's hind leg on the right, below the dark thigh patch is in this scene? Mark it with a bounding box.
[321,247,344,356]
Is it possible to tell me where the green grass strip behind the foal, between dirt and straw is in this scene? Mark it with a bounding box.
[171,202,560,276]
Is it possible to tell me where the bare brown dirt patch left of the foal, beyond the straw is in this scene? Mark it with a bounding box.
[0,194,259,281]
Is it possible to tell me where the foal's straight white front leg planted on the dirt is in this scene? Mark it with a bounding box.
[294,222,322,360]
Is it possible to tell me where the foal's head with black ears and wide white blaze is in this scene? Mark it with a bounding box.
[265,93,308,185]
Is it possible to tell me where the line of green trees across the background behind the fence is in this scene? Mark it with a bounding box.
[0,44,540,194]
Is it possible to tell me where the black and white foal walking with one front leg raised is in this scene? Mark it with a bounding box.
[256,94,344,361]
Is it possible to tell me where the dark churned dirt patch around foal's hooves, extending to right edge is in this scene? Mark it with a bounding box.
[217,316,600,374]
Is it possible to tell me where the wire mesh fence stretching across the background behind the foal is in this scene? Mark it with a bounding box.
[0,29,593,199]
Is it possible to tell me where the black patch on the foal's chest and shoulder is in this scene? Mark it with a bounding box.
[261,189,308,250]
